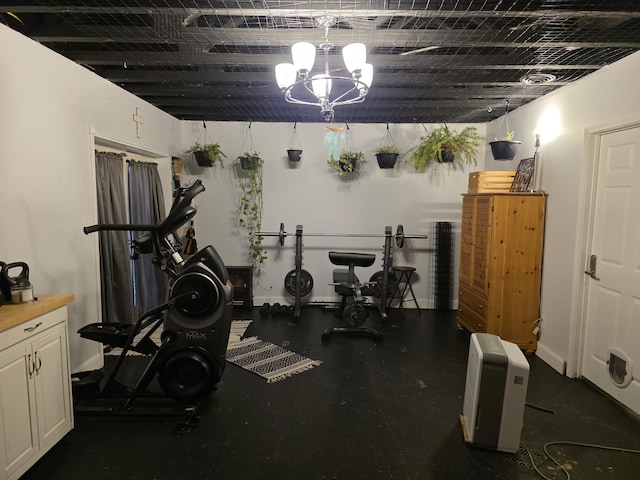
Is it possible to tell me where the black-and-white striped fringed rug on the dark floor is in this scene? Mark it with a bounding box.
[227,337,322,383]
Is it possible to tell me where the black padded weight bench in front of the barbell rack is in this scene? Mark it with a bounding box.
[322,252,384,342]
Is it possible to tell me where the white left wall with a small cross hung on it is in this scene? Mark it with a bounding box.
[0,25,180,370]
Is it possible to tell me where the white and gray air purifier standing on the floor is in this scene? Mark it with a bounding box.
[461,333,529,453]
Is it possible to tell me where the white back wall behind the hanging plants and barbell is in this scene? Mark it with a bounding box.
[182,121,485,307]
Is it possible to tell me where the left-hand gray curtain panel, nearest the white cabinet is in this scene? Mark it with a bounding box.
[96,151,133,323]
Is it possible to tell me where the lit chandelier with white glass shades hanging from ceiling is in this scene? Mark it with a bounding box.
[276,16,373,122]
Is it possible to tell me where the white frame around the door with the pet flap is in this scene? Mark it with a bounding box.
[566,118,640,377]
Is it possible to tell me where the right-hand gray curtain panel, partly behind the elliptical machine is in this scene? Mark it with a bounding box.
[128,160,168,315]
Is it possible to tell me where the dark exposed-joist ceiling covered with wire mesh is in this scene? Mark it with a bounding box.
[0,0,640,123]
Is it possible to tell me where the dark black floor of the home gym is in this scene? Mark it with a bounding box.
[23,307,640,480]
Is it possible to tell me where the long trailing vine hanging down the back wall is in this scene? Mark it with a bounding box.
[238,152,267,275]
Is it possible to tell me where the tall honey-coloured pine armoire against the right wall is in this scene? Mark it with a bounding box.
[457,193,546,352]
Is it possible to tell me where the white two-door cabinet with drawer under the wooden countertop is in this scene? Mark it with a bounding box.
[0,297,73,480]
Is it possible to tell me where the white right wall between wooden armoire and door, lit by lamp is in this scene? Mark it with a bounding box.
[486,53,640,373]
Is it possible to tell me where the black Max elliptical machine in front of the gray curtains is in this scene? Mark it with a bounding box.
[74,180,233,432]
